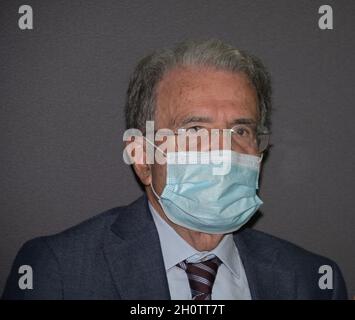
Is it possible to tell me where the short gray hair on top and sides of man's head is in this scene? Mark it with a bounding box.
[125,40,271,132]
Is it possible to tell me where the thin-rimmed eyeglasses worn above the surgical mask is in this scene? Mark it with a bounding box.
[154,123,270,153]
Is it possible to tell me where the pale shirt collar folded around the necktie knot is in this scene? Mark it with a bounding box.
[148,201,241,278]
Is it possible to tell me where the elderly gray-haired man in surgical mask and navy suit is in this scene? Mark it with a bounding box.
[3,40,347,300]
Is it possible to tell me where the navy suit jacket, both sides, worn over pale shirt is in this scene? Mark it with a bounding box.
[3,196,347,299]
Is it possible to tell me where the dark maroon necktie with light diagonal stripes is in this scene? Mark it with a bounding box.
[177,257,221,300]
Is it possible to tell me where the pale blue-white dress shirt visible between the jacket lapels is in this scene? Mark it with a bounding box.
[149,203,251,300]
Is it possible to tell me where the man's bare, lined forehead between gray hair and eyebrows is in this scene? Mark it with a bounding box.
[156,67,258,126]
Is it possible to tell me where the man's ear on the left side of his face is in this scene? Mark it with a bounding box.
[125,139,152,186]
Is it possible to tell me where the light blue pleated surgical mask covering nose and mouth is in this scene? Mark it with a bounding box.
[151,150,263,234]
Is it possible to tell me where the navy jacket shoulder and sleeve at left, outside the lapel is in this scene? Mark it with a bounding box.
[2,202,134,299]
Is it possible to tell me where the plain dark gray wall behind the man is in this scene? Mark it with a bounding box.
[0,0,355,296]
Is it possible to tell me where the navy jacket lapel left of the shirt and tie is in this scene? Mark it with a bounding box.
[104,197,170,300]
